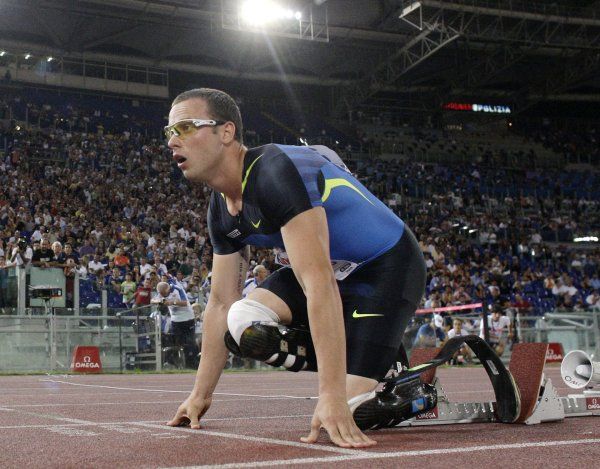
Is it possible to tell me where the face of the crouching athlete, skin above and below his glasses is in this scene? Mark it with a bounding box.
[168,98,224,182]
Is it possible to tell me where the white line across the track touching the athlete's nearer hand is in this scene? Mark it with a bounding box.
[162,438,600,469]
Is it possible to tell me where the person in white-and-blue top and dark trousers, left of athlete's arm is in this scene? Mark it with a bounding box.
[152,282,198,367]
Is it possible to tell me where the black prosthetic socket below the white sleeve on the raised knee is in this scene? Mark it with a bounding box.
[224,322,317,371]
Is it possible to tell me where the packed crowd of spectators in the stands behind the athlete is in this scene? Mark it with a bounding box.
[0,90,600,322]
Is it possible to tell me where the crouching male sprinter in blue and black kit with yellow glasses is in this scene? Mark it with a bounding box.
[165,88,436,447]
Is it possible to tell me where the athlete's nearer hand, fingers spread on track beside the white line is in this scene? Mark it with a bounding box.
[301,395,377,448]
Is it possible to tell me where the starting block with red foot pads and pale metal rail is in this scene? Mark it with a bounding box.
[398,344,600,427]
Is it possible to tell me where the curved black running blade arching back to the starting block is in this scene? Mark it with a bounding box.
[384,335,521,423]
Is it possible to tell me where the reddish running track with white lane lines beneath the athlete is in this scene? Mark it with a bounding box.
[0,368,600,469]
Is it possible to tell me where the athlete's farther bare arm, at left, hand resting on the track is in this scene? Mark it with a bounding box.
[168,248,249,428]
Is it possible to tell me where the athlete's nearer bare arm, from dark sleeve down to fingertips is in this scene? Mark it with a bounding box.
[281,207,373,447]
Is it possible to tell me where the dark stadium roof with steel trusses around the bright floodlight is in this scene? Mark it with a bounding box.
[0,0,600,113]
